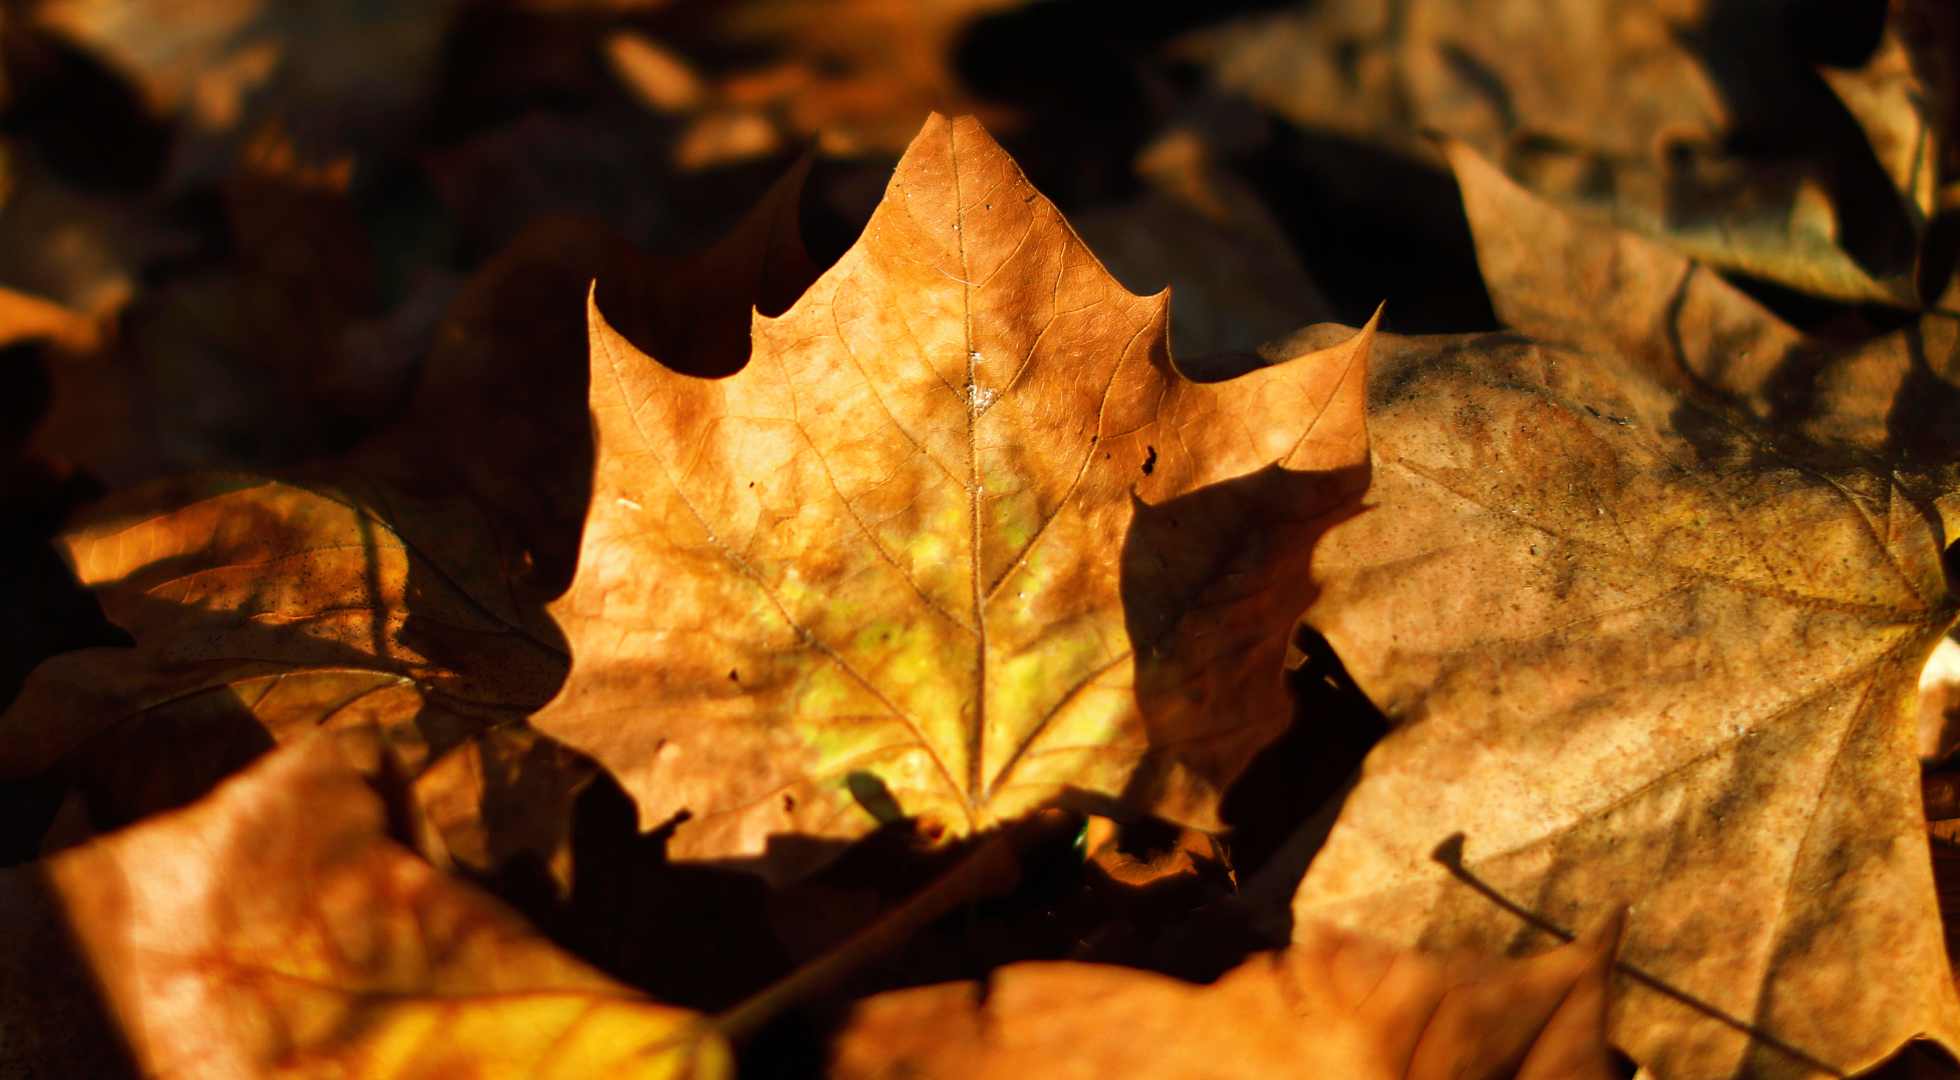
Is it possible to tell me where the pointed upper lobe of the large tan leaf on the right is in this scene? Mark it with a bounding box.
[1446,143,1960,491]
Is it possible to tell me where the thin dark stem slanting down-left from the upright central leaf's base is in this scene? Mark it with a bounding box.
[711,811,1074,1043]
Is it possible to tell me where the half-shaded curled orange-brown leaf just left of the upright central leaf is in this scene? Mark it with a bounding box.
[0,478,590,876]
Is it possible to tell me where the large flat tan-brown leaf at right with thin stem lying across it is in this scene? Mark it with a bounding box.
[1294,145,1960,1076]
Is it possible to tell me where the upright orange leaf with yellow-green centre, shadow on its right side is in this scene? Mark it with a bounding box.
[533,116,1372,870]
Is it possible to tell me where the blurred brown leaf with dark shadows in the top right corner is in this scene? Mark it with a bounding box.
[1184,0,1940,306]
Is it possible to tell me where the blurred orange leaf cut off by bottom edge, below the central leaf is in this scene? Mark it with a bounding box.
[831,919,1619,1080]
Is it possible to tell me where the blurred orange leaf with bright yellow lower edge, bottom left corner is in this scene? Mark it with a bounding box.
[0,737,733,1078]
